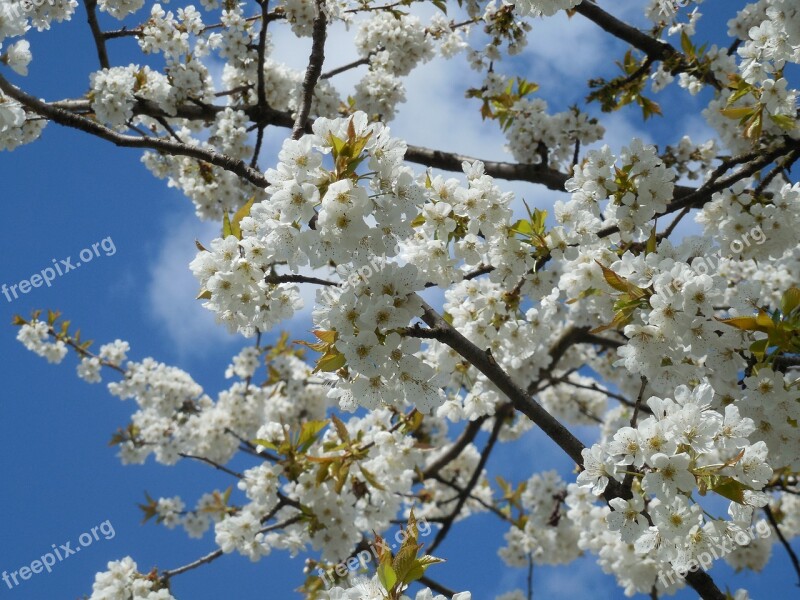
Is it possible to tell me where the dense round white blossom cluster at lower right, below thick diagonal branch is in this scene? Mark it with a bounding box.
[567,384,772,592]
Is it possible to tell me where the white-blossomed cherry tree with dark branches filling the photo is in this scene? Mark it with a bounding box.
[0,0,800,600]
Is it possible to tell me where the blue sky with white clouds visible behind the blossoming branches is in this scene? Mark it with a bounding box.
[0,0,793,600]
